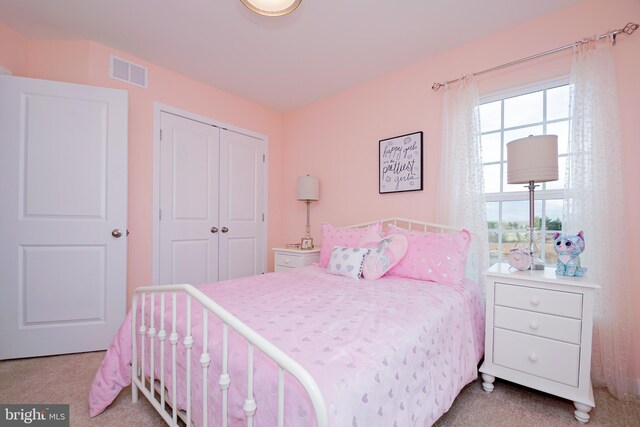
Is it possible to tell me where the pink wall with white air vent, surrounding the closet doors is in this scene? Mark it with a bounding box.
[0,22,283,304]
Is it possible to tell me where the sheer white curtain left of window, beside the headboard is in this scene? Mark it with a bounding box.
[438,76,489,288]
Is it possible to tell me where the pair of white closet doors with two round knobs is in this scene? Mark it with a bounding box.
[159,112,265,284]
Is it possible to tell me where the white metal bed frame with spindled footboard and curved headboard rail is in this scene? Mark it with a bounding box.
[131,218,459,427]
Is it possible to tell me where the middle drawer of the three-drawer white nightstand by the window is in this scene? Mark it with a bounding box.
[493,306,582,344]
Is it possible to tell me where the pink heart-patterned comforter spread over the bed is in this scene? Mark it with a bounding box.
[89,266,484,427]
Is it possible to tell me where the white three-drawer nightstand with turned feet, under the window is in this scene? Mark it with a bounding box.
[480,263,600,423]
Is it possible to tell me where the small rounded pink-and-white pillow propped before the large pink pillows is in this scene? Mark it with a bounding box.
[362,234,409,280]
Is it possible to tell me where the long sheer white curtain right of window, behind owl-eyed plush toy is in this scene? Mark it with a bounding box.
[563,39,635,399]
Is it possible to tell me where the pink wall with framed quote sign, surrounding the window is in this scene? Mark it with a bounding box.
[282,0,640,377]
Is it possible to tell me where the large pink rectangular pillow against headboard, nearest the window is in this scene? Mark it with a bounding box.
[387,225,471,284]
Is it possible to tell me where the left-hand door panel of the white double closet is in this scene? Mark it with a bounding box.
[159,112,220,285]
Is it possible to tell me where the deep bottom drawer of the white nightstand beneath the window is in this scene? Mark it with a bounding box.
[493,328,580,387]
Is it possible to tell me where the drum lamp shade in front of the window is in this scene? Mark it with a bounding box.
[507,135,558,184]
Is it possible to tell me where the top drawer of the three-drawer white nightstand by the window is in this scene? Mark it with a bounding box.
[495,283,582,319]
